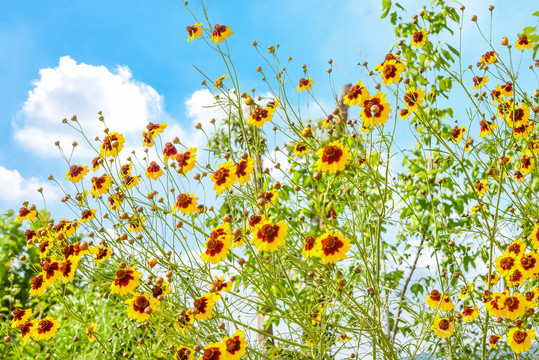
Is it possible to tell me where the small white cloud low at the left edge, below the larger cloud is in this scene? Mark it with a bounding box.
[0,166,60,208]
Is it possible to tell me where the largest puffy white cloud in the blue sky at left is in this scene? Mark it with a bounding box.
[13,56,163,156]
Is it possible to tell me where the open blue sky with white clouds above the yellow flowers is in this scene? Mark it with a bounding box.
[0,0,537,217]
